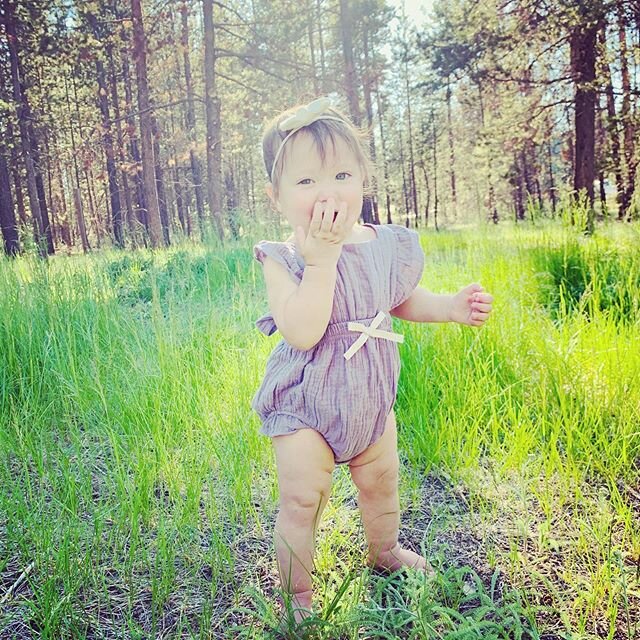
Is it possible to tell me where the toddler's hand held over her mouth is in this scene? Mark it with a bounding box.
[295,198,359,267]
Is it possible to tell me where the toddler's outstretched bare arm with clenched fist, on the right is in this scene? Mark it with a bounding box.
[391,284,493,327]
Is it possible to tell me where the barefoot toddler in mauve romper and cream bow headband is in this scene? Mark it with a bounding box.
[252,98,493,620]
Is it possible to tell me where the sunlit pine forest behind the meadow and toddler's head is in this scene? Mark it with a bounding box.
[0,0,640,256]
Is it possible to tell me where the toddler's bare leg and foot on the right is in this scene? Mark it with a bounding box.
[349,411,427,571]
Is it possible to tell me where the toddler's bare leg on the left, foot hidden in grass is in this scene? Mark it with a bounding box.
[272,429,334,620]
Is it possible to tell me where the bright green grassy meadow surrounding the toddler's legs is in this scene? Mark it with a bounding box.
[0,222,640,640]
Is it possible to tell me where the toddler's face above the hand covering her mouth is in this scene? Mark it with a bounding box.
[274,132,364,232]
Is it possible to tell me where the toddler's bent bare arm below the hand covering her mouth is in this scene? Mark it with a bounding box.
[264,257,337,351]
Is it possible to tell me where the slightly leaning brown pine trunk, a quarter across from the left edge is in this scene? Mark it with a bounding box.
[131,0,163,248]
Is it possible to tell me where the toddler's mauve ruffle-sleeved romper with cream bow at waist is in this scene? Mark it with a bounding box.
[252,224,424,462]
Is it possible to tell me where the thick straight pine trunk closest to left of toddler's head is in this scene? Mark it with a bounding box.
[202,0,224,241]
